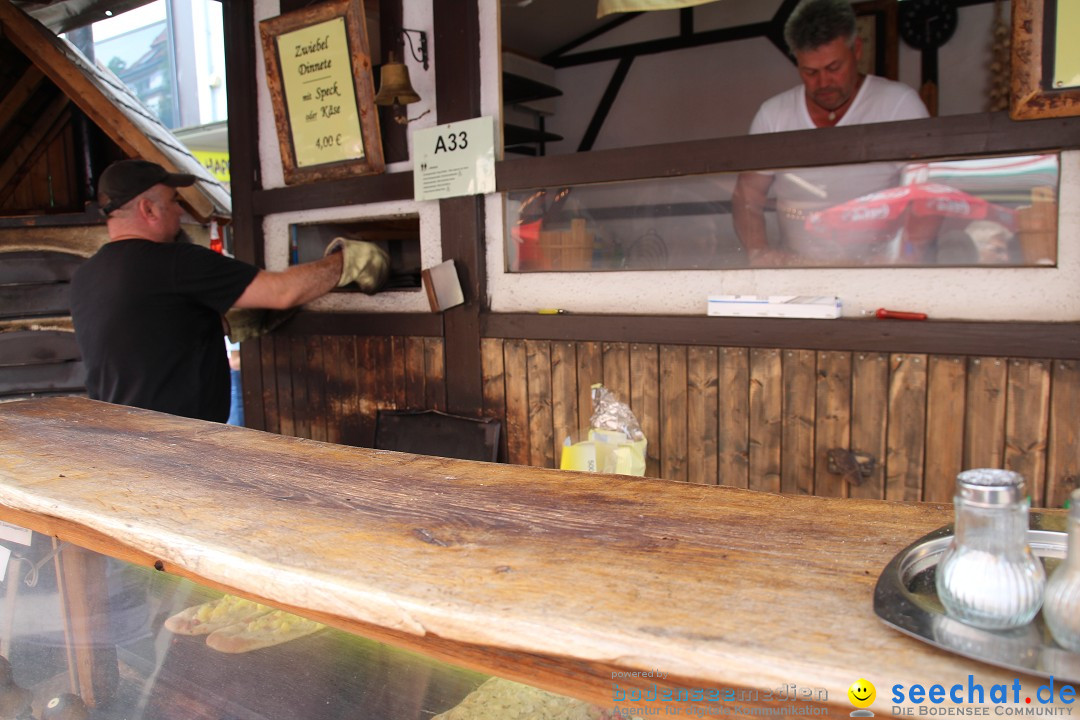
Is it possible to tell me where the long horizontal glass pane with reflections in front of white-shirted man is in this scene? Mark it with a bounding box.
[505,153,1059,272]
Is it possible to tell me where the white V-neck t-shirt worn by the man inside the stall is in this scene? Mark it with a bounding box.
[750,76,929,261]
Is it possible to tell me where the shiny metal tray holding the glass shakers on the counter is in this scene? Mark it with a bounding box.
[874,513,1080,683]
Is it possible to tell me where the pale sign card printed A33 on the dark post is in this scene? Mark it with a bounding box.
[413,118,495,200]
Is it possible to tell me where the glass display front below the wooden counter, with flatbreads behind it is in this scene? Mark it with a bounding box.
[0,526,608,720]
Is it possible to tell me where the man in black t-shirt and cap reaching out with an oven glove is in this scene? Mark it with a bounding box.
[71,160,389,422]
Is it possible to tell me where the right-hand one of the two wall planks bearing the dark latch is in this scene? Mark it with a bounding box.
[848,353,889,500]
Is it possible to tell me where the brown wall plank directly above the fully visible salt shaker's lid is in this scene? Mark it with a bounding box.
[963,357,1009,467]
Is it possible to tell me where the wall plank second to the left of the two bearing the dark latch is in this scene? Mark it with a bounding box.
[748,348,783,492]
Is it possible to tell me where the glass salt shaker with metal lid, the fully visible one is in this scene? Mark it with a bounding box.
[935,468,1047,629]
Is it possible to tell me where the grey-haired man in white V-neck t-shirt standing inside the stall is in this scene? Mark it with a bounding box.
[731,0,928,266]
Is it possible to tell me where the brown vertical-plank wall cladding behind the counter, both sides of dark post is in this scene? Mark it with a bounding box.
[245,335,1080,507]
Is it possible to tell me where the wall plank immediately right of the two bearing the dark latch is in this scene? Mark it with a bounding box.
[885,354,927,500]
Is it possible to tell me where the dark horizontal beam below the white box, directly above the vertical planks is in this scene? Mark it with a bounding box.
[483,313,1080,359]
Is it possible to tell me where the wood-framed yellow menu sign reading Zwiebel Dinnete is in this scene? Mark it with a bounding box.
[259,0,384,185]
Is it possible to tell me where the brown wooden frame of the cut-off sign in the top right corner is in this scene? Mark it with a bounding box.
[1009,0,1080,120]
